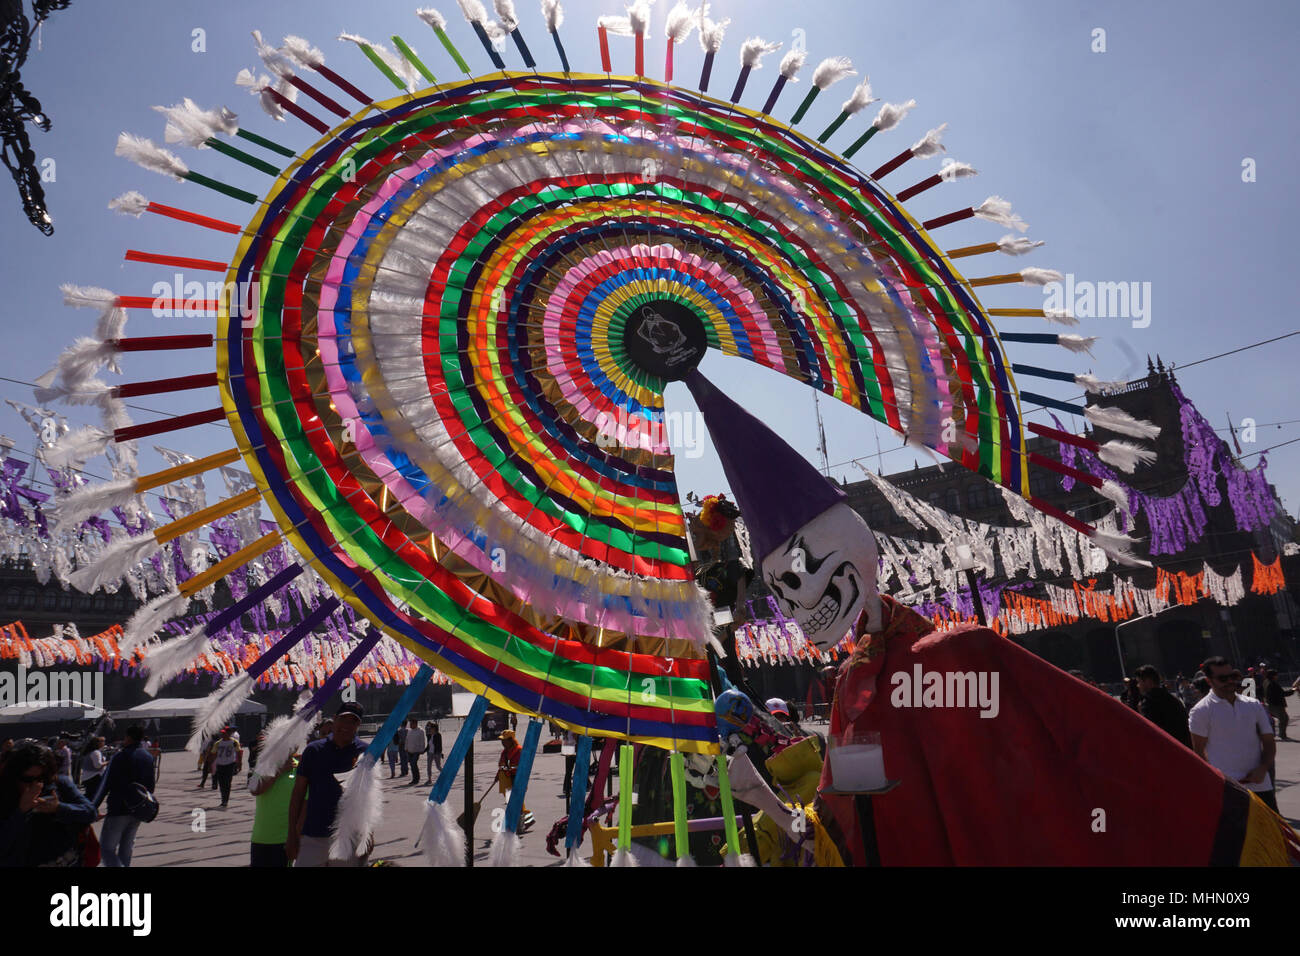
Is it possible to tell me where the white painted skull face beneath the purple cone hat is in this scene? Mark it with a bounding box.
[763,503,880,650]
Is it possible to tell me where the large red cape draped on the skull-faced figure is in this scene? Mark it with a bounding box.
[822,598,1271,866]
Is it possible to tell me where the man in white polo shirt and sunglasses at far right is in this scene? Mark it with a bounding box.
[1187,657,1278,812]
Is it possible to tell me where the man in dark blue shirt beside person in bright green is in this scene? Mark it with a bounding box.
[285,704,369,866]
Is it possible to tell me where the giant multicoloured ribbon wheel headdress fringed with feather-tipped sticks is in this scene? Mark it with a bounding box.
[45,0,1145,752]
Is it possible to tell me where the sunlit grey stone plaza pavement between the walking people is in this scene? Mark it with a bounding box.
[116,705,1300,866]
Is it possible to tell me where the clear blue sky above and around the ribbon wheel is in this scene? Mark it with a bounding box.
[0,0,1300,514]
